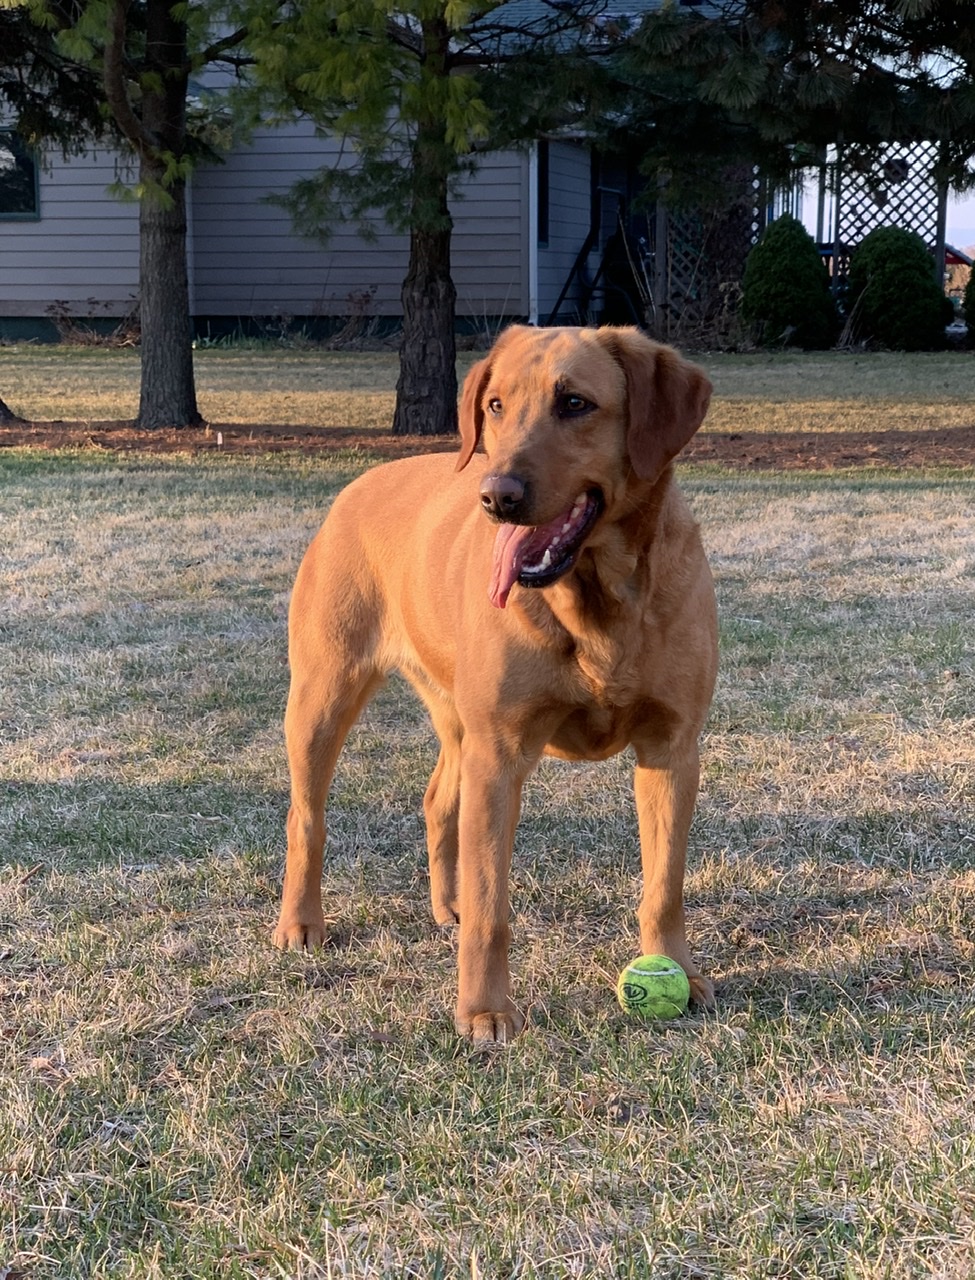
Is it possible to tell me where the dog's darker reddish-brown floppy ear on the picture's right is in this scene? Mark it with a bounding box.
[609,329,711,480]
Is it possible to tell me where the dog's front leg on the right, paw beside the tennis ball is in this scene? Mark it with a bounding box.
[635,742,714,1006]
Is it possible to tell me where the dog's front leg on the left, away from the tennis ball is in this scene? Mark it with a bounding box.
[454,737,528,1044]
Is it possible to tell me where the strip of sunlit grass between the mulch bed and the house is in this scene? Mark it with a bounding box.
[0,346,975,431]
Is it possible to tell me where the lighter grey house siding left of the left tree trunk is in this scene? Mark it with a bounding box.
[0,151,138,317]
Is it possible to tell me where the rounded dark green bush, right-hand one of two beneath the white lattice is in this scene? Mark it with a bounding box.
[847,227,953,351]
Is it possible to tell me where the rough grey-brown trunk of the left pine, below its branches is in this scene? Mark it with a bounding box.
[137,157,202,428]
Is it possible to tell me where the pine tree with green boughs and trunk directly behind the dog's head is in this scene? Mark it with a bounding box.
[246,0,601,434]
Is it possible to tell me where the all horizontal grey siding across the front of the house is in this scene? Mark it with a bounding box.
[0,127,532,324]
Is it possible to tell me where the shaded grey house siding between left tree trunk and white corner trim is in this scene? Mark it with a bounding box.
[191,125,527,317]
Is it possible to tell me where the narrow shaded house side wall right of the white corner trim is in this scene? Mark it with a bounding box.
[539,141,590,324]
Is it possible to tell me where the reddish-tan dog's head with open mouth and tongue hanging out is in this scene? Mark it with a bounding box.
[457,325,711,607]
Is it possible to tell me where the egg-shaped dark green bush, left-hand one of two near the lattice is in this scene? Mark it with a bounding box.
[741,215,839,351]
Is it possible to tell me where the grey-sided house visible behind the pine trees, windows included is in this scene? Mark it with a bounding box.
[0,115,612,340]
